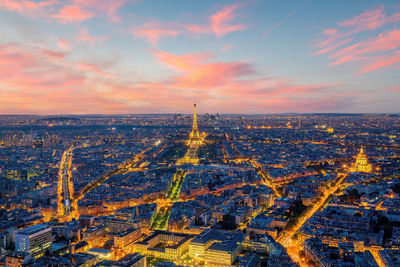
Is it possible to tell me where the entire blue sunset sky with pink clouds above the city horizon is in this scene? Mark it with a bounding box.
[0,0,400,114]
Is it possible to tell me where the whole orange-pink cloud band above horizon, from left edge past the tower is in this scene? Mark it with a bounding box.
[0,43,353,114]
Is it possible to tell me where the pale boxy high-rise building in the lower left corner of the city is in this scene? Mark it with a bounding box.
[15,224,52,258]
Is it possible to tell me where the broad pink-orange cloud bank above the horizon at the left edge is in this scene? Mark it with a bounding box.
[0,43,127,114]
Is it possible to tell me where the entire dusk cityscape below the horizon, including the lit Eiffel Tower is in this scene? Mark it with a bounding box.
[0,108,400,266]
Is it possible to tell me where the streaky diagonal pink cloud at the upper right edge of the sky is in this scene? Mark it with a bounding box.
[314,6,400,74]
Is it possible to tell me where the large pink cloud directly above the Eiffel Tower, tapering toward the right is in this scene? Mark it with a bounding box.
[148,50,352,113]
